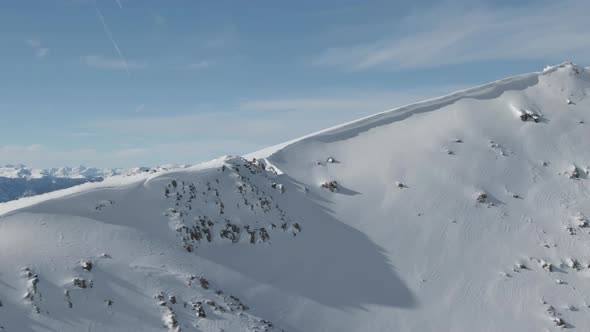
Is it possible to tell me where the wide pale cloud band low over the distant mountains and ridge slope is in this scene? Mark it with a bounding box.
[0,86,468,167]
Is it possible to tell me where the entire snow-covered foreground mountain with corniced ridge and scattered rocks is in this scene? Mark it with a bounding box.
[0,63,590,332]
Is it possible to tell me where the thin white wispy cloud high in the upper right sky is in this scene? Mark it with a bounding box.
[313,0,590,70]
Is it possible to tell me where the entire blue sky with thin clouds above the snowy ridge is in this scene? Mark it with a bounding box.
[0,0,590,167]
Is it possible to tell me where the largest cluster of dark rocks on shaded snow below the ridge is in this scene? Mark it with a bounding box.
[164,157,293,252]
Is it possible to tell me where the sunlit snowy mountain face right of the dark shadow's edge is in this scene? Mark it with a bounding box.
[253,64,590,331]
